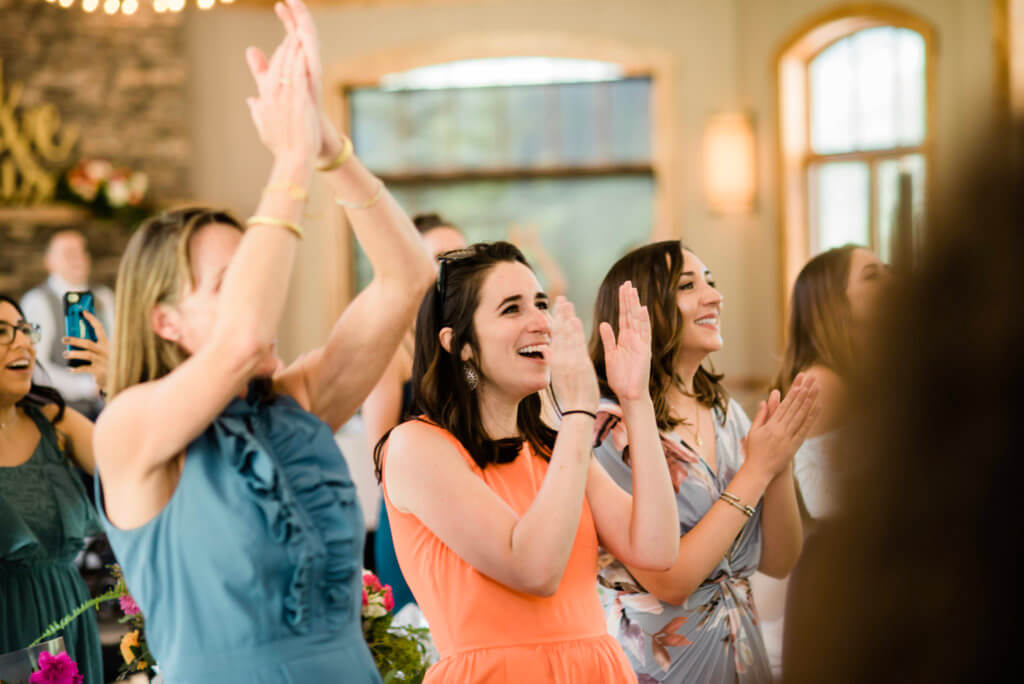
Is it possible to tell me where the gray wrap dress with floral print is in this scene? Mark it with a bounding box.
[594,400,771,684]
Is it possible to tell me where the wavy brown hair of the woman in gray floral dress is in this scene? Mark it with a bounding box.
[590,240,729,432]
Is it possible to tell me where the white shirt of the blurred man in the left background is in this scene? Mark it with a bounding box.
[22,275,114,401]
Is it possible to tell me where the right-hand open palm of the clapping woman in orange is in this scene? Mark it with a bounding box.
[598,281,650,402]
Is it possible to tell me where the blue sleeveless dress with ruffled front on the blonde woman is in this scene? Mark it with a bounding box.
[96,388,380,684]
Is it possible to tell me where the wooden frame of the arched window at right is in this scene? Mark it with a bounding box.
[775,4,938,335]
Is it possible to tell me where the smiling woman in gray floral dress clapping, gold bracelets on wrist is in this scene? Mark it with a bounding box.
[591,241,817,684]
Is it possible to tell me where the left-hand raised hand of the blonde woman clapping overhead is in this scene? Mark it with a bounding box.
[246,23,322,160]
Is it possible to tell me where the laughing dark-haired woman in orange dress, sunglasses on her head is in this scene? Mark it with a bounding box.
[375,243,678,684]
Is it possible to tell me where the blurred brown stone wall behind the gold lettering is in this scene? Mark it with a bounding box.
[0,0,189,295]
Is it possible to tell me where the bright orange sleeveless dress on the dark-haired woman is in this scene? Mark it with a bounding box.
[383,426,637,684]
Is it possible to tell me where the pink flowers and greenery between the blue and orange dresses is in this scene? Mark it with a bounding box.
[362,570,430,684]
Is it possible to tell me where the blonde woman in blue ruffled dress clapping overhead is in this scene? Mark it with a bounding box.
[94,0,434,684]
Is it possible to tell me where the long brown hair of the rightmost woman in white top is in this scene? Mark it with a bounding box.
[772,245,865,395]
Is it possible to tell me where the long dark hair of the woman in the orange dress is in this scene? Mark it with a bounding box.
[374,242,555,480]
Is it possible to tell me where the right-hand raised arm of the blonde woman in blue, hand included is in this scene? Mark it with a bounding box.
[262,0,435,429]
